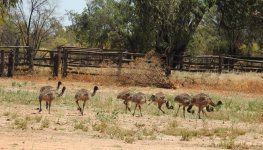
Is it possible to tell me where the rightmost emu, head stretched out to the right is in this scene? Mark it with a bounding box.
[187,93,223,119]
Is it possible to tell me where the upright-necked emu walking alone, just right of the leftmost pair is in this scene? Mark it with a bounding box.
[75,86,99,116]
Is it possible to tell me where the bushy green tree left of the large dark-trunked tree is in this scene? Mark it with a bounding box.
[69,0,139,49]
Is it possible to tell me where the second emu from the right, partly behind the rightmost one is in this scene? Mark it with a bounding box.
[174,93,194,118]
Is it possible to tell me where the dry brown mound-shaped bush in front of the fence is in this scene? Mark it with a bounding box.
[118,50,174,88]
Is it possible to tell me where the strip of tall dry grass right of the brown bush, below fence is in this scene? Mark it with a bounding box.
[170,71,263,93]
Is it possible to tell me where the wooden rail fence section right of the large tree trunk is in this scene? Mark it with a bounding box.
[174,55,263,73]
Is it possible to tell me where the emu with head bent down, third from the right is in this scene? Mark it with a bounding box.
[148,92,174,113]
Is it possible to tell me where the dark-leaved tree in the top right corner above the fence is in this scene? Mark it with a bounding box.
[217,0,263,55]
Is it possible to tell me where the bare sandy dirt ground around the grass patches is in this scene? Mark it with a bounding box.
[0,78,263,150]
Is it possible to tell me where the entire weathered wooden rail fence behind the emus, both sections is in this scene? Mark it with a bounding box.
[0,46,263,77]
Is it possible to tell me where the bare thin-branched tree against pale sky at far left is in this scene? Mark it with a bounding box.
[13,0,56,49]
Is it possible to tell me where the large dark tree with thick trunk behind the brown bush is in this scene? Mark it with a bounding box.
[135,0,218,75]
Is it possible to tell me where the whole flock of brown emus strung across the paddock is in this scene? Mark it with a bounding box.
[39,81,223,119]
